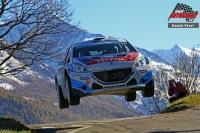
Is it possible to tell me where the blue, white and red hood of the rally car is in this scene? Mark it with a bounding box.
[73,52,139,70]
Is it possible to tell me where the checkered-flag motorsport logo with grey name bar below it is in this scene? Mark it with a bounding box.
[168,3,199,28]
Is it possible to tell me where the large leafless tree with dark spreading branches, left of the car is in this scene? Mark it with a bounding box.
[0,0,75,76]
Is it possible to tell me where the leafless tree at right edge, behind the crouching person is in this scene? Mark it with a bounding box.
[172,45,200,93]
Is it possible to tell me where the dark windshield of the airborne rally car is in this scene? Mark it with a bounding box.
[73,43,137,57]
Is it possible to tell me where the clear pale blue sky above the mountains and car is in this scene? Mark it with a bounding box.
[69,0,200,51]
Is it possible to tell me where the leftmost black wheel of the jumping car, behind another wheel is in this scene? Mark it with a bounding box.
[56,83,69,109]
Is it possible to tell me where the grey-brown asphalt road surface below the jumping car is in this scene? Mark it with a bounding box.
[30,107,200,133]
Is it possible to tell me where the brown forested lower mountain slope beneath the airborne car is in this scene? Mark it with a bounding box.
[0,88,142,124]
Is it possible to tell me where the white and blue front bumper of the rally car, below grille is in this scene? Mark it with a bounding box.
[70,66,154,95]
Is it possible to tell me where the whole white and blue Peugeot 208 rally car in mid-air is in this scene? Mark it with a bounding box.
[55,37,154,108]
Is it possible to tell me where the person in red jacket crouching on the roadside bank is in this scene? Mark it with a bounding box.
[168,79,190,103]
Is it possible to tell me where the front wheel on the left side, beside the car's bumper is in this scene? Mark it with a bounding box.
[66,76,80,106]
